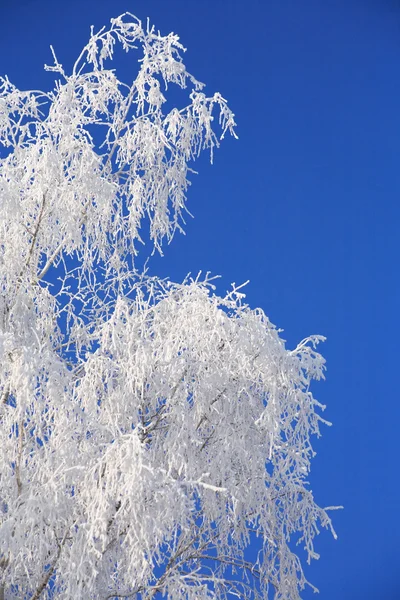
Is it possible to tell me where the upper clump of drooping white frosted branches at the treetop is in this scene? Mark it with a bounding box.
[0,15,235,294]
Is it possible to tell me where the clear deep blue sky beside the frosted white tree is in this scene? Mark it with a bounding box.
[0,0,400,600]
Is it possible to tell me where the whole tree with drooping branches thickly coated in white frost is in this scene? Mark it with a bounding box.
[0,14,338,600]
